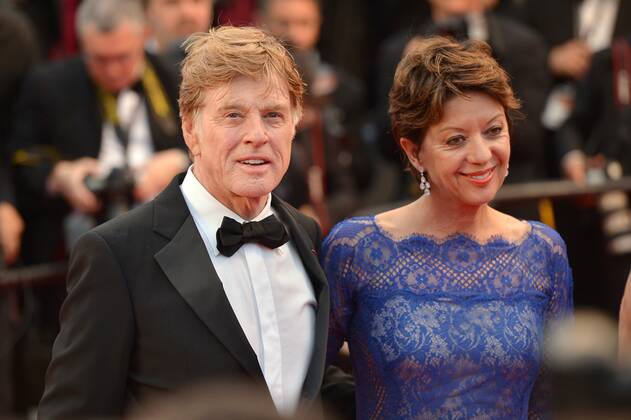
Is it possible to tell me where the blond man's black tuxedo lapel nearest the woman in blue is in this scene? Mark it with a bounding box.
[272,195,330,401]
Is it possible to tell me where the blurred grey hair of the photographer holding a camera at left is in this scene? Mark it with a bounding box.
[75,0,145,36]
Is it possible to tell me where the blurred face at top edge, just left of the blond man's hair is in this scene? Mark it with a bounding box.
[147,0,213,50]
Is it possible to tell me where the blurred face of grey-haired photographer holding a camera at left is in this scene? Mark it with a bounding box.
[81,22,145,92]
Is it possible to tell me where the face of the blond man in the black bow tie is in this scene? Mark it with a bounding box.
[182,76,295,209]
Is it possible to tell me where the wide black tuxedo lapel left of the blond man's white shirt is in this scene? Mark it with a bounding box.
[154,176,263,380]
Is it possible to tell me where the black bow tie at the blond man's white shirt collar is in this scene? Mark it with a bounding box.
[217,215,289,257]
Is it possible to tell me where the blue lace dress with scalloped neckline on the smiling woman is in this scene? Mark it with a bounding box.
[321,217,572,419]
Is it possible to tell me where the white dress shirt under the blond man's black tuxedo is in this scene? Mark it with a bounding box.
[180,166,316,414]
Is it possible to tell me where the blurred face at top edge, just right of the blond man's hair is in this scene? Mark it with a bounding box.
[261,0,321,51]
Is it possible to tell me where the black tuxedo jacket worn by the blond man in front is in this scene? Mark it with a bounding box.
[39,174,329,418]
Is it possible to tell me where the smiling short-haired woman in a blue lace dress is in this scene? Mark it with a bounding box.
[321,37,572,419]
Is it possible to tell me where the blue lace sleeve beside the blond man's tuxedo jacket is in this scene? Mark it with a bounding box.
[320,222,353,364]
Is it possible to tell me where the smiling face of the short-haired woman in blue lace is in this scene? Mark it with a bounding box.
[401,92,510,207]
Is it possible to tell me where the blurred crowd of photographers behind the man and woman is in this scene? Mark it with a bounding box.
[0,0,631,414]
